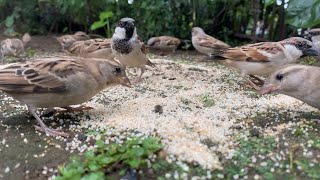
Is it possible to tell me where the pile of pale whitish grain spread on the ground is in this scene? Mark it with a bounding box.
[68,59,315,169]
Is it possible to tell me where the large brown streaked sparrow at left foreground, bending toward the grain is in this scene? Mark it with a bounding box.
[0,57,130,136]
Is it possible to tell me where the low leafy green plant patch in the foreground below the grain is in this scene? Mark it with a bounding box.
[56,137,163,180]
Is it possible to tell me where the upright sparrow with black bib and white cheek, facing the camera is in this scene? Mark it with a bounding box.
[111,18,154,82]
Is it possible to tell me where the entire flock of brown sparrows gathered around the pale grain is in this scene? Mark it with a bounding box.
[0,17,320,137]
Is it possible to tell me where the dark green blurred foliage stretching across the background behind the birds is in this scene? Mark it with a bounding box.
[0,0,320,45]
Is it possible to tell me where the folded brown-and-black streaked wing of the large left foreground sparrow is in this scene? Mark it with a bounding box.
[0,57,85,93]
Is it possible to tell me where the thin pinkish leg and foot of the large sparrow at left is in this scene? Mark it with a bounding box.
[27,106,69,137]
